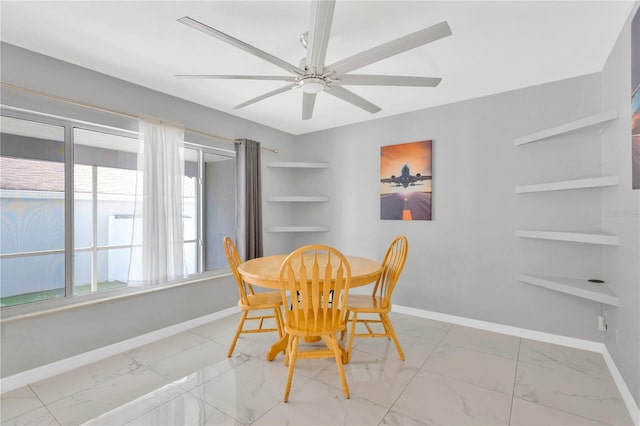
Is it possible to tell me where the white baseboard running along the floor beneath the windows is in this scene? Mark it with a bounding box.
[0,306,239,393]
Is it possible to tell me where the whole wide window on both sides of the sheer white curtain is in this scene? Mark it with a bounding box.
[0,110,236,307]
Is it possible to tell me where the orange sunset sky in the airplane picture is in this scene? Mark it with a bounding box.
[380,141,431,192]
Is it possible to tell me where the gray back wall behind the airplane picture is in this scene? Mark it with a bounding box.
[298,75,602,341]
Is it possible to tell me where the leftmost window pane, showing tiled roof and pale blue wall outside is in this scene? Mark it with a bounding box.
[0,117,65,306]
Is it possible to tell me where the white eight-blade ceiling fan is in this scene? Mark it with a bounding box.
[176,0,451,120]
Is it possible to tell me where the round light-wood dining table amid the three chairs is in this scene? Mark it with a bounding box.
[238,254,382,361]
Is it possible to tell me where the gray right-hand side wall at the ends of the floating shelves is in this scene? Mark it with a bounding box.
[602,3,640,405]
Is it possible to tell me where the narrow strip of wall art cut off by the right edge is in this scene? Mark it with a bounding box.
[631,6,640,189]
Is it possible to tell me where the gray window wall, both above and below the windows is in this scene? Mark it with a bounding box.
[0,43,294,377]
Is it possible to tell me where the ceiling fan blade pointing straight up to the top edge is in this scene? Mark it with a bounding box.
[307,0,336,74]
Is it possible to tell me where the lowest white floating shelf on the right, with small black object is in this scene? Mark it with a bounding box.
[518,274,620,306]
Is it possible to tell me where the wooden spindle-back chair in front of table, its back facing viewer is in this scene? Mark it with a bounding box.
[280,245,351,402]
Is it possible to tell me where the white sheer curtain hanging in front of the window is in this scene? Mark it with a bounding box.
[129,118,185,285]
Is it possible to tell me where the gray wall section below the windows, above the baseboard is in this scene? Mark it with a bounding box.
[0,276,238,377]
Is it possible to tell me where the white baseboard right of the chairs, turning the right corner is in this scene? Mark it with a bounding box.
[392,305,640,425]
